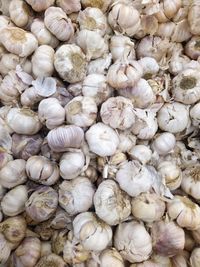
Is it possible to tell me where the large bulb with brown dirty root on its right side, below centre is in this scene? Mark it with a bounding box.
[94,180,131,225]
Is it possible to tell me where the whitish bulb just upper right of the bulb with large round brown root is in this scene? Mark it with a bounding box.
[76,30,108,61]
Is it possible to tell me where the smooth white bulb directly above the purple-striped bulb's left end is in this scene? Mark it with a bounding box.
[38,97,65,130]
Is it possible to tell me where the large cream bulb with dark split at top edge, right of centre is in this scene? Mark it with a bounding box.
[108,1,140,37]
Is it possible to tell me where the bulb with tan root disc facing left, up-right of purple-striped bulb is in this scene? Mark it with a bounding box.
[65,96,98,127]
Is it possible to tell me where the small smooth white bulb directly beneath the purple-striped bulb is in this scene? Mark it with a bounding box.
[59,150,85,180]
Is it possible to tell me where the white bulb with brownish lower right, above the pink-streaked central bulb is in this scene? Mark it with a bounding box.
[82,73,113,105]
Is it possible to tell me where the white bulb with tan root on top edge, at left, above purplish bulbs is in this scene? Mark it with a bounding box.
[6,108,42,135]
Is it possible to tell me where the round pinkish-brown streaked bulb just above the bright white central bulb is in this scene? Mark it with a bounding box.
[100,96,135,130]
